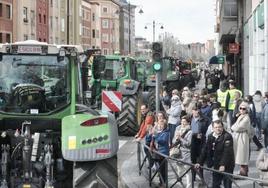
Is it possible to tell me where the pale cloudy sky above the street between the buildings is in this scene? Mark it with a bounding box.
[131,0,216,43]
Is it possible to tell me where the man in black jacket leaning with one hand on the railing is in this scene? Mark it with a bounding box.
[195,120,235,188]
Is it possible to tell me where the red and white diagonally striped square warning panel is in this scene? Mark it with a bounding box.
[101,91,122,112]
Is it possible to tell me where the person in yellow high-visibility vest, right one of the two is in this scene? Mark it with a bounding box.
[226,80,243,129]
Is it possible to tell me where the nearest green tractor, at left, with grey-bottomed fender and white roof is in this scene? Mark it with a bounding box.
[0,41,119,188]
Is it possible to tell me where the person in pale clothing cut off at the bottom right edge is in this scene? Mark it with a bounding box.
[256,148,268,187]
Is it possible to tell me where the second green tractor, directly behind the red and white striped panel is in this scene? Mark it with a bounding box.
[89,55,142,136]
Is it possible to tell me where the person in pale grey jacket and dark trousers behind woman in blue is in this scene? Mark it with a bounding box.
[166,95,182,145]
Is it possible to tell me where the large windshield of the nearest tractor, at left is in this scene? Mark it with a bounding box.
[0,55,70,114]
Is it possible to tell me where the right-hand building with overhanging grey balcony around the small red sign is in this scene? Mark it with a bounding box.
[215,0,243,86]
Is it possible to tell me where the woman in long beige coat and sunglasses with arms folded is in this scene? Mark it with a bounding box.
[231,102,251,176]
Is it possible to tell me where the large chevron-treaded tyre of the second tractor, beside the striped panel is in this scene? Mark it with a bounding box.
[117,95,142,136]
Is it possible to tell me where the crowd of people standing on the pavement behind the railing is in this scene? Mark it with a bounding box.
[135,74,268,188]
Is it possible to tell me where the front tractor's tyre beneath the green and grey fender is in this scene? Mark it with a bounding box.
[73,156,118,188]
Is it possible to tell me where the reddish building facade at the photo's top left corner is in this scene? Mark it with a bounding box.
[0,0,13,43]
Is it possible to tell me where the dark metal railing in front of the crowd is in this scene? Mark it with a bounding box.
[137,142,268,188]
